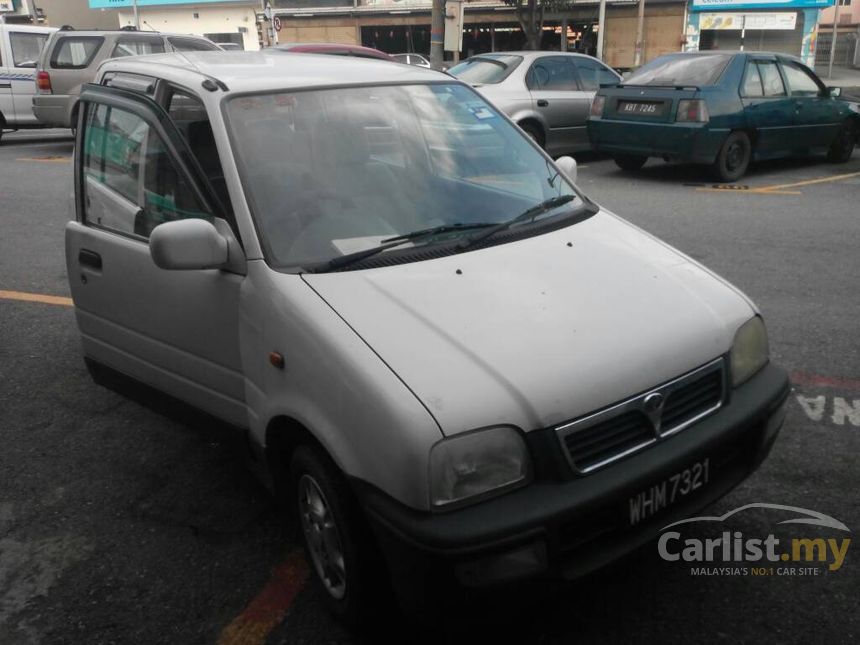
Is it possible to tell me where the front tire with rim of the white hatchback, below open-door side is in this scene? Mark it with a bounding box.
[290,445,388,631]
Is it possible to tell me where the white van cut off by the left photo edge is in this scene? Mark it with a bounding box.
[0,22,56,139]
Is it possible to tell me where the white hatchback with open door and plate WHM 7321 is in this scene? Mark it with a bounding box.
[66,50,789,623]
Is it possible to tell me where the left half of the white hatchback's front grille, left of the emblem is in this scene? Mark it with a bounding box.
[564,410,656,471]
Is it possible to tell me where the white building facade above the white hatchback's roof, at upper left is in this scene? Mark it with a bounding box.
[89,0,260,50]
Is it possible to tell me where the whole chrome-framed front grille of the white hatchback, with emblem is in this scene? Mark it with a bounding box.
[555,358,725,474]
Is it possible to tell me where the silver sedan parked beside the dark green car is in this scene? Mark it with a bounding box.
[448,52,621,156]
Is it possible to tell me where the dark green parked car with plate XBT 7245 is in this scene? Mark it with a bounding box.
[588,51,860,181]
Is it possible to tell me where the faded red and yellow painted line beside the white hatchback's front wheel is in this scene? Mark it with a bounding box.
[218,551,309,645]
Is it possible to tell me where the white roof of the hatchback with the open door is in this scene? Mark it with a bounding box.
[99,50,446,93]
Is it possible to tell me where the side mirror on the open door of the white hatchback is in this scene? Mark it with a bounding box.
[149,219,230,271]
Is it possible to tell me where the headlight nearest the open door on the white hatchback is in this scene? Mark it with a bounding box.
[430,427,531,508]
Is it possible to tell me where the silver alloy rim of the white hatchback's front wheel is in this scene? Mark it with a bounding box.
[298,475,346,600]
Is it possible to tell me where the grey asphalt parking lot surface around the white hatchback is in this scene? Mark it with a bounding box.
[0,131,860,645]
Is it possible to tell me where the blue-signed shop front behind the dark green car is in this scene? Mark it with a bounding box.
[685,0,833,66]
